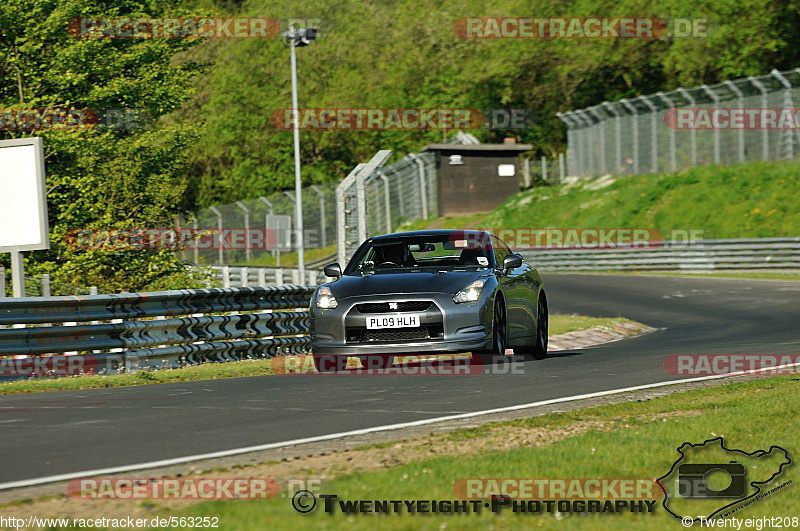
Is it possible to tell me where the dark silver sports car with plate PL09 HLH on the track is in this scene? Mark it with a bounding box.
[311,230,547,372]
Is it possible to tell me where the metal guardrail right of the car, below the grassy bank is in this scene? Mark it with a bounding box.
[521,238,800,271]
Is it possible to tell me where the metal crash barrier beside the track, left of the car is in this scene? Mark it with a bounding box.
[0,285,314,377]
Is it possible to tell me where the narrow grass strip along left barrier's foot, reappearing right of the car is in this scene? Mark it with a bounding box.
[0,315,629,395]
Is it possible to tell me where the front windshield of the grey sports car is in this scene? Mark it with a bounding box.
[345,235,492,275]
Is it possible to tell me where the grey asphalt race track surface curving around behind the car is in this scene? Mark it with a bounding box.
[0,274,800,483]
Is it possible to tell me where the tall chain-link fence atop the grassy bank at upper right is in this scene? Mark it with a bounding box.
[558,68,800,177]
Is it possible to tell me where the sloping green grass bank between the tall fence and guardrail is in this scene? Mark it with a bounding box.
[401,162,800,238]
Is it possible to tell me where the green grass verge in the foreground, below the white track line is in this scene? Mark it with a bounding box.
[175,376,800,530]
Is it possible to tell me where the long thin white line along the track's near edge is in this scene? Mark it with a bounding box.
[0,363,800,490]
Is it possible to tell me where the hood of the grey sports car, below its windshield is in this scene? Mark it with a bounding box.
[328,269,491,300]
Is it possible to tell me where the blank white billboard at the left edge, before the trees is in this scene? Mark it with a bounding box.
[0,137,50,252]
